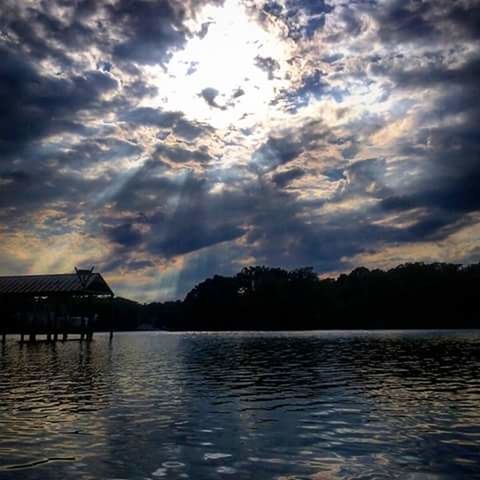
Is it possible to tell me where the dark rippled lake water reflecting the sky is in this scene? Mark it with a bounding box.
[0,331,480,480]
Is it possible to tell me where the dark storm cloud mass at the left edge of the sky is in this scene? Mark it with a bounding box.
[0,34,132,224]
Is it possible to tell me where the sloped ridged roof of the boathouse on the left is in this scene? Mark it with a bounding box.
[0,269,113,296]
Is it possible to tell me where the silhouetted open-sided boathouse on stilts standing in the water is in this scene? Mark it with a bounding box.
[0,268,114,342]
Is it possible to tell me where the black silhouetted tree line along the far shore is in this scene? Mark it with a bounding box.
[107,263,480,331]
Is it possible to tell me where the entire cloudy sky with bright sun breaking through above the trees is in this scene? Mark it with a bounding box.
[0,0,480,301]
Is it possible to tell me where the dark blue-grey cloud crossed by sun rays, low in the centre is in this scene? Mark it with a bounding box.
[102,167,248,257]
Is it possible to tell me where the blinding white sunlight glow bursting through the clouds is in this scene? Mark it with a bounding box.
[145,0,290,128]
